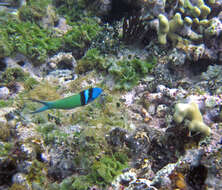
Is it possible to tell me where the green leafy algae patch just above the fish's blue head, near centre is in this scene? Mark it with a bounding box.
[77,48,157,90]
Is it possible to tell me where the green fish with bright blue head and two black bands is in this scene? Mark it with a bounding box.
[30,87,103,114]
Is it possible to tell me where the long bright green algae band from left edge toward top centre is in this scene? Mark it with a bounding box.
[0,11,101,65]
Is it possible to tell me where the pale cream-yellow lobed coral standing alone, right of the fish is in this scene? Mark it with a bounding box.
[174,102,211,136]
